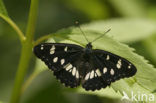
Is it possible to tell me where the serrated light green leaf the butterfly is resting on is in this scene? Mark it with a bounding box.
[31,20,156,101]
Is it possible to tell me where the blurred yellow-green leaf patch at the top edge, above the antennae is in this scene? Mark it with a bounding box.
[64,0,109,20]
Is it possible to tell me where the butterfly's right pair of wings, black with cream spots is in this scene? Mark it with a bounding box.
[82,49,137,91]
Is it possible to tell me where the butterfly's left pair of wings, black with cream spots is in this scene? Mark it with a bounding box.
[34,43,83,87]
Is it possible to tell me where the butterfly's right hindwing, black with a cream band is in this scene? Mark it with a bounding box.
[82,54,110,91]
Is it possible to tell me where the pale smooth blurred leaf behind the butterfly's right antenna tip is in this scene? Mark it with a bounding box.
[82,18,156,43]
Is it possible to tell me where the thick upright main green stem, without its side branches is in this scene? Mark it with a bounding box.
[10,0,38,103]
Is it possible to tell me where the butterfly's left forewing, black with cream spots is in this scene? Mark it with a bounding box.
[34,43,82,71]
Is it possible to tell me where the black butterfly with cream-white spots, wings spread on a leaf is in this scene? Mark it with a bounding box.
[34,28,137,91]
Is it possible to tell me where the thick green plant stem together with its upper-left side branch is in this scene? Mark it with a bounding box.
[0,0,38,103]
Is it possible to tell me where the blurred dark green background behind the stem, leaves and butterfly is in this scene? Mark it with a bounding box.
[0,0,156,103]
